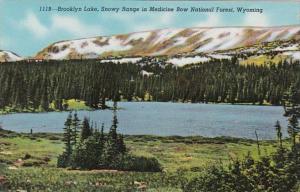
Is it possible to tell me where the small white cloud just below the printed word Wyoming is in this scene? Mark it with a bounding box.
[243,13,270,27]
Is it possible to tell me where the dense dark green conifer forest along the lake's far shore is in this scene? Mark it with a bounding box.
[0,58,300,111]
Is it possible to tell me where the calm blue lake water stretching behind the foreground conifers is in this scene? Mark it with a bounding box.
[0,102,287,139]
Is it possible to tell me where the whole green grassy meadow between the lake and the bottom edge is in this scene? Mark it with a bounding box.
[0,133,288,191]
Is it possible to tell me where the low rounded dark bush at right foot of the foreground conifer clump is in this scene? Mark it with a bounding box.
[120,155,162,172]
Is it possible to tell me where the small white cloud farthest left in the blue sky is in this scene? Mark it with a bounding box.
[21,12,48,37]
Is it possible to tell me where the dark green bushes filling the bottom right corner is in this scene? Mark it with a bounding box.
[183,149,300,192]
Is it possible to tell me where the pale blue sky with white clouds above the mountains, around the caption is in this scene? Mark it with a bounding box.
[0,0,300,56]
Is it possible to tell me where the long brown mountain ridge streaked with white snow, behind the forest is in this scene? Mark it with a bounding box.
[36,26,300,59]
